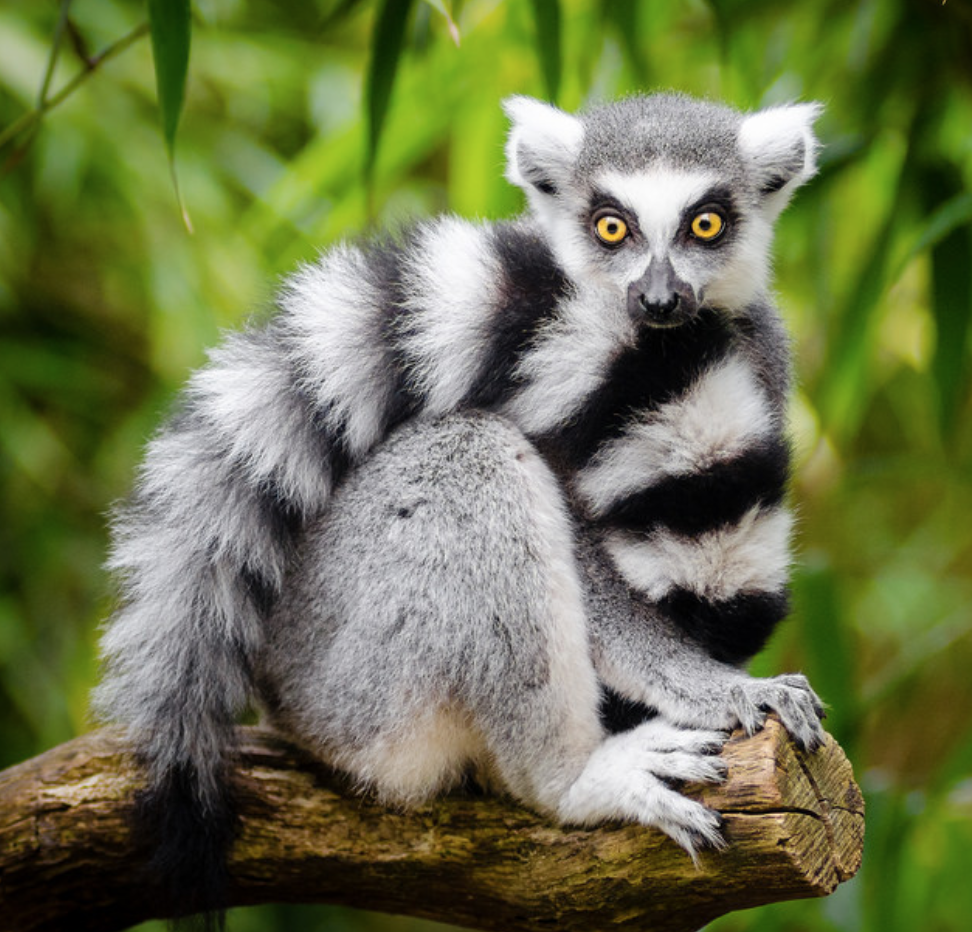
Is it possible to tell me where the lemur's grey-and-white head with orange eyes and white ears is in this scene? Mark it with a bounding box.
[504,94,820,326]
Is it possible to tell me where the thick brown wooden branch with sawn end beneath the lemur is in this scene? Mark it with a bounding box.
[0,720,864,932]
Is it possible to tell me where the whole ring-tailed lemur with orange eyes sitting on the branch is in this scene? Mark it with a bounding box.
[96,95,822,924]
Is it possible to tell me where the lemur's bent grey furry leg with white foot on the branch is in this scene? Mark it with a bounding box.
[260,415,723,851]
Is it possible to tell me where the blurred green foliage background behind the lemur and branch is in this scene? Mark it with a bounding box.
[0,0,972,932]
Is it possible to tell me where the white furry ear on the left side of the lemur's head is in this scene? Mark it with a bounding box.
[503,97,584,194]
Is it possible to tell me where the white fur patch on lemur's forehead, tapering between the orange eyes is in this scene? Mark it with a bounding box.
[594,165,719,245]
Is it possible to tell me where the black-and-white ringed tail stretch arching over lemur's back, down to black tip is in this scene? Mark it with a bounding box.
[95,220,540,912]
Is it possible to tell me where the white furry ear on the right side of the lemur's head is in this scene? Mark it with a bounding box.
[739,103,823,212]
